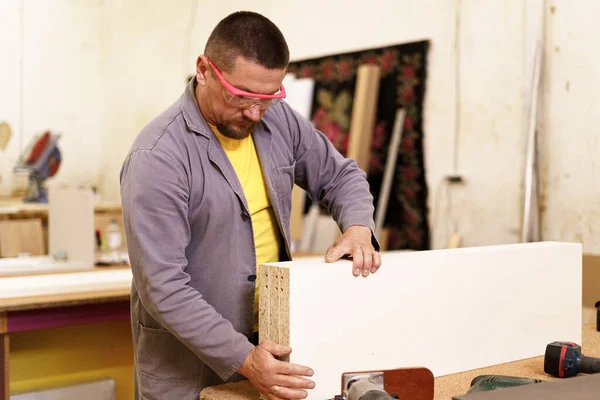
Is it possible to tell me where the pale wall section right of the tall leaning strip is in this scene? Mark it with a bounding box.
[541,0,600,253]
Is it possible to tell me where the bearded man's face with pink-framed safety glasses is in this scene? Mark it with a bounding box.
[199,57,286,139]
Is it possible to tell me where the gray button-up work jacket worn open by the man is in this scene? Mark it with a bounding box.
[121,80,376,400]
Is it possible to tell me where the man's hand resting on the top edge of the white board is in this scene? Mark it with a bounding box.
[325,225,381,277]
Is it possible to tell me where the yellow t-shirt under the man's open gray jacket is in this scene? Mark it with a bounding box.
[210,125,280,332]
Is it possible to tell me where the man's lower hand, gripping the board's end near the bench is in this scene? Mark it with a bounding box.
[238,340,315,400]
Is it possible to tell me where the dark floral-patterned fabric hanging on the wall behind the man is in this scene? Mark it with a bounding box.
[289,41,430,250]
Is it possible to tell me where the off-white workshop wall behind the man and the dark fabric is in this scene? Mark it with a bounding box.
[0,0,600,252]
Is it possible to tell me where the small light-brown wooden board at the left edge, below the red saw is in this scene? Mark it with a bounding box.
[0,218,46,257]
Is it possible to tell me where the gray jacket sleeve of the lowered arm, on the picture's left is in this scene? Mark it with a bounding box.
[121,148,253,380]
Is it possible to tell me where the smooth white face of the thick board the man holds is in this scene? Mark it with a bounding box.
[261,242,582,399]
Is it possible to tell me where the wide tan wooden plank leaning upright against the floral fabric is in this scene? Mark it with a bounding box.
[347,64,381,172]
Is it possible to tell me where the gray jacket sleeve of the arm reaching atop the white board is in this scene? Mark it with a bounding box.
[282,103,380,250]
